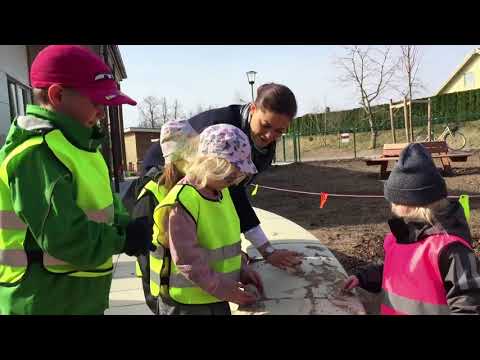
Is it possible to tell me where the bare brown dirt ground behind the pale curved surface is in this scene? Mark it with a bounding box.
[252,153,480,314]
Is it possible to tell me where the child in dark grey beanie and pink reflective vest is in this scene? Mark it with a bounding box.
[344,144,480,315]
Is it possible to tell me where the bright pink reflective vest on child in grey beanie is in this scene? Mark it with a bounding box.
[380,233,472,315]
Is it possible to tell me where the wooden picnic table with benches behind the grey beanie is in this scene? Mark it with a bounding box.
[364,141,473,179]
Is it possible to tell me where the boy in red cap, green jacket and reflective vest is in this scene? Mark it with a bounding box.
[0,45,151,314]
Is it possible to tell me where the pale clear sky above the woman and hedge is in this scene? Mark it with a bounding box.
[120,45,479,127]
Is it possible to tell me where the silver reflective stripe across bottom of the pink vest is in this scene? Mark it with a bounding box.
[382,290,450,315]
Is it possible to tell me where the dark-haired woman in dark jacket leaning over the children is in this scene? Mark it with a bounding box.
[138,83,300,268]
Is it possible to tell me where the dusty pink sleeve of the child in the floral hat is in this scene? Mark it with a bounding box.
[168,205,235,300]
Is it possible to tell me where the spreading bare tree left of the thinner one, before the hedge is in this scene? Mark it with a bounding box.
[336,45,397,149]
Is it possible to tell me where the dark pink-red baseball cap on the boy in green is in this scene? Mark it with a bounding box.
[30,45,137,105]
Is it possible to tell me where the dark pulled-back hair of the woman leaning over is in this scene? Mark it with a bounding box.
[255,83,297,118]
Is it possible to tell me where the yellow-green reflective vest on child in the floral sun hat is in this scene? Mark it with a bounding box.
[150,185,241,304]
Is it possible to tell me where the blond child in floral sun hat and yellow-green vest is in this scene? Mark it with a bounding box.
[151,124,263,315]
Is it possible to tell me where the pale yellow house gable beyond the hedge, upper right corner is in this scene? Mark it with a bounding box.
[437,48,480,95]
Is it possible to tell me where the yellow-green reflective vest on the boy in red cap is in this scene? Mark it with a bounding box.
[0,130,114,284]
